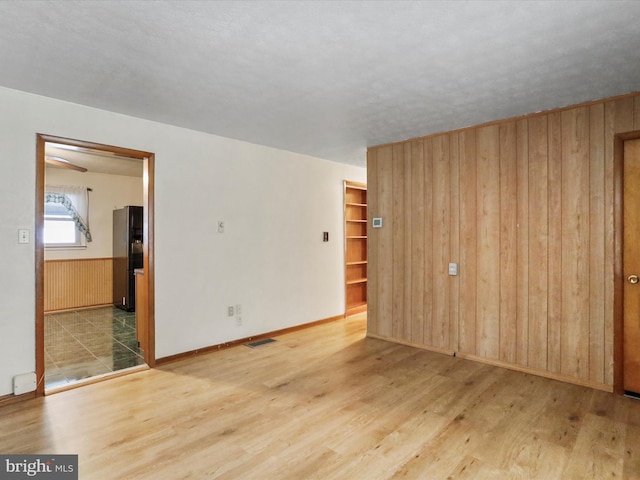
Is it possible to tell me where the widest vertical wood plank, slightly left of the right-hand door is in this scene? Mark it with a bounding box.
[561,107,590,379]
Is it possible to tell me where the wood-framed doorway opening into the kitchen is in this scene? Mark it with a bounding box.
[35,134,155,395]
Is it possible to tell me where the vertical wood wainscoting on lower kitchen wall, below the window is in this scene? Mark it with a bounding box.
[44,258,113,312]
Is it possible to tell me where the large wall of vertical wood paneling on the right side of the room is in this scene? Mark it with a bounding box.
[367,94,640,390]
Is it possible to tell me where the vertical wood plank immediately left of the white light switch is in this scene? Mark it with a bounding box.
[432,135,451,348]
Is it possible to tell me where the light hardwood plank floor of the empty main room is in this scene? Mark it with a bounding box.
[0,315,640,480]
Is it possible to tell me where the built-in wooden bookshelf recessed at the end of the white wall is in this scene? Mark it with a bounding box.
[344,181,367,315]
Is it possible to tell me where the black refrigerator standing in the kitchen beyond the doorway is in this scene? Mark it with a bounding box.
[113,206,143,312]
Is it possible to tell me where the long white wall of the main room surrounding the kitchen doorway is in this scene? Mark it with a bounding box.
[0,88,366,395]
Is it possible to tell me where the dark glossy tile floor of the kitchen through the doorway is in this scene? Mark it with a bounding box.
[44,306,144,390]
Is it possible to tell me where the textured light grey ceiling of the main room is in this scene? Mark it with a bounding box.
[0,0,640,166]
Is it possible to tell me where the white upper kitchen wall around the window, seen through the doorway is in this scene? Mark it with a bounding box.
[44,168,144,260]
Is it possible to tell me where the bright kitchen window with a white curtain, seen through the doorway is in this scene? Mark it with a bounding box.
[44,186,91,248]
